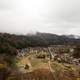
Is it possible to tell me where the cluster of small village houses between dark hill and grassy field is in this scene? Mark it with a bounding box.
[18,45,80,64]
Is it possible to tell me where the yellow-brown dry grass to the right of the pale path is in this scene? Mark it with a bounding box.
[51,62,80,80]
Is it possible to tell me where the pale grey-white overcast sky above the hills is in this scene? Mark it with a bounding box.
[0,0,80,35]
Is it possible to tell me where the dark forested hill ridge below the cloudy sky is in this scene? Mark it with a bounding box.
[0,32,80,54]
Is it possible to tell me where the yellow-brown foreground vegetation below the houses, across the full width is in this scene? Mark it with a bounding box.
[0,55,80,80]
